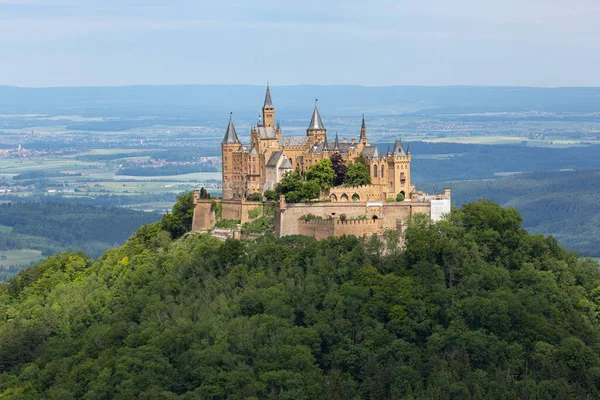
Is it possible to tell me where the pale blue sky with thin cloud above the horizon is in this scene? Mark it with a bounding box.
[0,0,600,87]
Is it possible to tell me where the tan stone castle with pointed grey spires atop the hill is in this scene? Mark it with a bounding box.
[192,85,450,238]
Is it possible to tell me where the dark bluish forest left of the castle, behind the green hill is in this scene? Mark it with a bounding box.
[0,202,160,266]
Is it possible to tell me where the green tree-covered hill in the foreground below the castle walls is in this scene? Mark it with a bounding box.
[0,202,600,400]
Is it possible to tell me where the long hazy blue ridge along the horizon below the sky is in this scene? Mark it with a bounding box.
[0,85,600,122]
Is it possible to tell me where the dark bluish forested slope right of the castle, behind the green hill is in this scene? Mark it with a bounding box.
[418,170,600,257]
